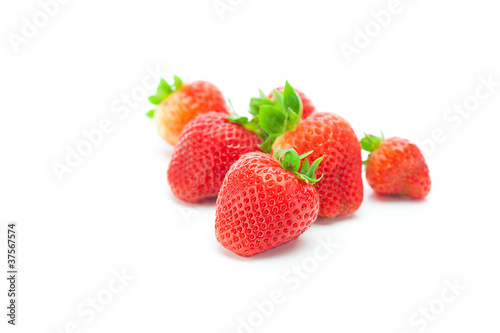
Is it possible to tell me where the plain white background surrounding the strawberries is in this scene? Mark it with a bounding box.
[0,0,500,333]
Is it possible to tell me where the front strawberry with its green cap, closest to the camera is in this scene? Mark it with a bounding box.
[215,149,321,257]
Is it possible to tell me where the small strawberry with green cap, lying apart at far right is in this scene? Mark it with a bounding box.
[361,135,431,199]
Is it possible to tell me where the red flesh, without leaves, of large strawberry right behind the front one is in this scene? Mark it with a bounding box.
[273,112,363,217]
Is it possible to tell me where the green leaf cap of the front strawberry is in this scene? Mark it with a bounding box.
[273,148,324,185]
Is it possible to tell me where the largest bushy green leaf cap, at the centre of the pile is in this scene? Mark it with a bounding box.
[228,81,303,153]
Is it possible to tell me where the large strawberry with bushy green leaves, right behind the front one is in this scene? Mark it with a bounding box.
[234,82,363,217]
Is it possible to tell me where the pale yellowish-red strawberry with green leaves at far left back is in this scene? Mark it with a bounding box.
[147,75,228,145]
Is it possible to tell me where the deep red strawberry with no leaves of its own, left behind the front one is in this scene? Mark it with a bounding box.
[167,112,261,202]
